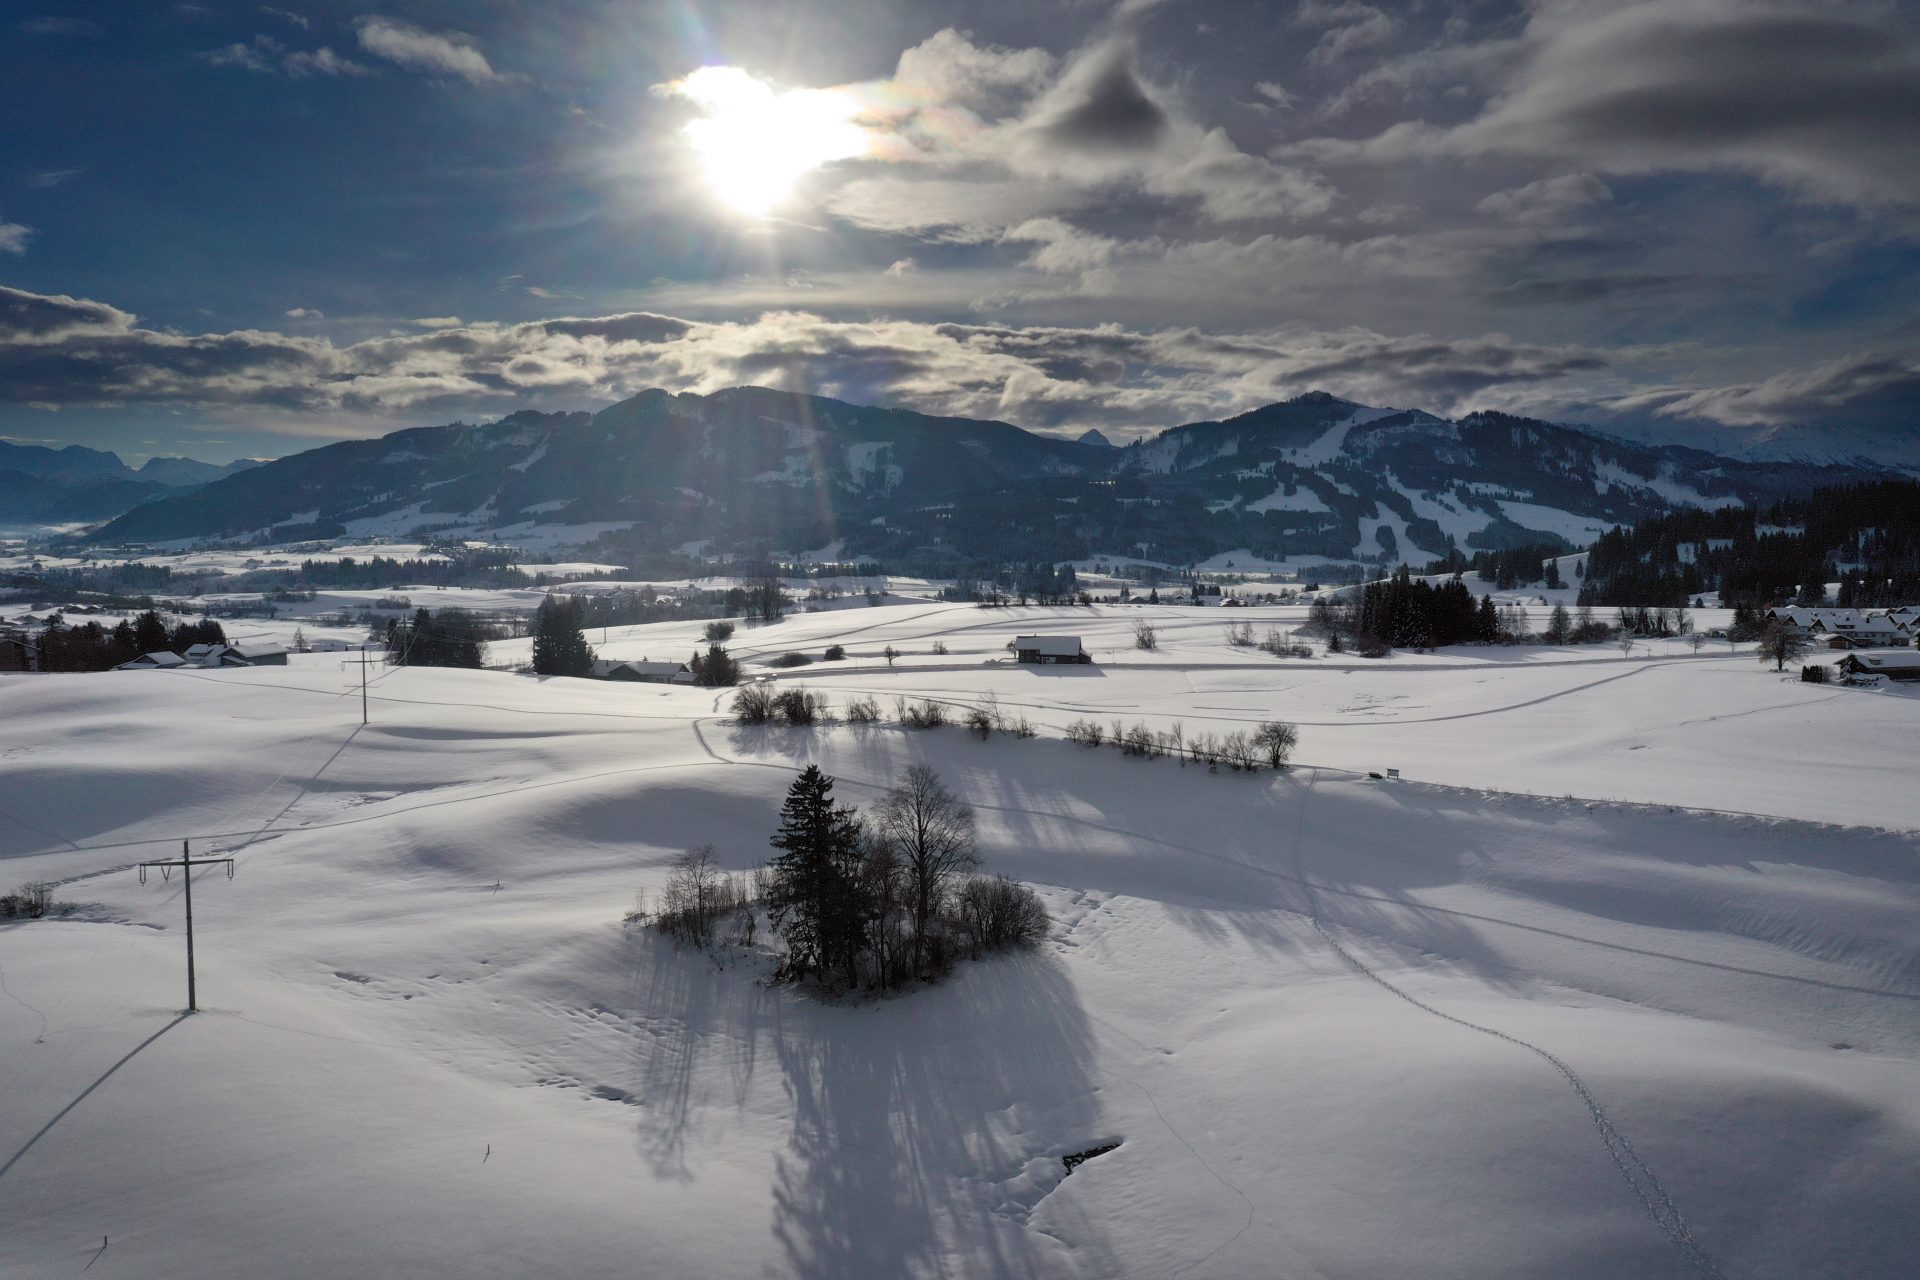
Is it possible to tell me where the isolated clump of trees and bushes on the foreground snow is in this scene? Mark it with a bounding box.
[628,764,1048,992]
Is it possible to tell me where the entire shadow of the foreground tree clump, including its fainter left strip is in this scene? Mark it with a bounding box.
[628,938,1116,1280]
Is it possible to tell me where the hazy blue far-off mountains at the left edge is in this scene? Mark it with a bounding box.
[0,439,257,524]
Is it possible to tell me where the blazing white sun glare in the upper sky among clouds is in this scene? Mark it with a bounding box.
[674,67,868,217]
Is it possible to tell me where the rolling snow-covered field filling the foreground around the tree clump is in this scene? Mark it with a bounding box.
[0,604,1920,1280]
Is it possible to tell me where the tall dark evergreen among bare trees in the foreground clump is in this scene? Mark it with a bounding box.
[766,764,866,986]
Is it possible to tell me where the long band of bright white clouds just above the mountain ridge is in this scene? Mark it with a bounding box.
[0,284,1607,434]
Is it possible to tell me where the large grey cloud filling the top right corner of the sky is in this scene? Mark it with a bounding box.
[1298,0,1920,207]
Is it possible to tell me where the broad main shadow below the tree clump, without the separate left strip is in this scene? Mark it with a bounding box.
[774,956,1116,1280]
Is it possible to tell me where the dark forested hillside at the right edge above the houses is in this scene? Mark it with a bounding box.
[1580,480,1920,608]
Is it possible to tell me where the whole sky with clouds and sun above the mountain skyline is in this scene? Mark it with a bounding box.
[0,0,1920,461]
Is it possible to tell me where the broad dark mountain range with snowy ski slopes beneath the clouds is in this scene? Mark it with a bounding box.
[86,388,1884,564]
